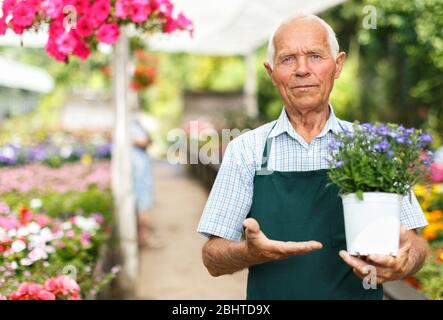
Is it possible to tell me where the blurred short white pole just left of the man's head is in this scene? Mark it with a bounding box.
[243,51,258,118]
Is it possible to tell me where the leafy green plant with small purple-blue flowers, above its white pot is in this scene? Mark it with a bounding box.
[329,123,432,199]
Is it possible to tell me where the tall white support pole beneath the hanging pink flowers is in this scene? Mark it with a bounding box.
[112,28,138,296]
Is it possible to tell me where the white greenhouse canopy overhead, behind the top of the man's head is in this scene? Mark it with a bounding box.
[148,0,344,55]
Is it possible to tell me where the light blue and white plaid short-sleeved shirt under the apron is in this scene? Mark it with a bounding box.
[197,107,428,240]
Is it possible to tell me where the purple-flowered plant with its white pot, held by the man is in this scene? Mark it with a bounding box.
[329,123,432,256]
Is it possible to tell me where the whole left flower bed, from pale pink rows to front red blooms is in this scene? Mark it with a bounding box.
[0,154,117,299]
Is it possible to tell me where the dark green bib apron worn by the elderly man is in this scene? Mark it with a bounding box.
[247,122,383,300]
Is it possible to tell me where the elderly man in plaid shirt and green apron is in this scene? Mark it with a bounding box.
[198,15,429,299]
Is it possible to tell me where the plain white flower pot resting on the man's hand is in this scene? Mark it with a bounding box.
[341,192,403,256]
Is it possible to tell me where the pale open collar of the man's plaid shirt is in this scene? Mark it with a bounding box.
[269,105,342,139]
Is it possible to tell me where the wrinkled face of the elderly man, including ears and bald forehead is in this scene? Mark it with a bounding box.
[265,18,345,111]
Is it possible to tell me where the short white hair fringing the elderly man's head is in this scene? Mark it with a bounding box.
[268,14,340,68]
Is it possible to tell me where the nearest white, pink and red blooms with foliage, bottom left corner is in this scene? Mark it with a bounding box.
[0,203,117,300]
